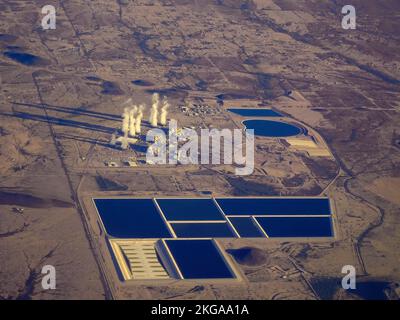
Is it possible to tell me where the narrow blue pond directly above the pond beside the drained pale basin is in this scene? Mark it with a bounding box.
[171,222,236,238]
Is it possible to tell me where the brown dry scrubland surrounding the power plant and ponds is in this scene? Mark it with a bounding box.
[0,0,400,299]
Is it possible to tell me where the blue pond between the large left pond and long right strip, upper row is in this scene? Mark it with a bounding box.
[156,198,225,221]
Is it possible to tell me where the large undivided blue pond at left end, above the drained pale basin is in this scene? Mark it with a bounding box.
[94,199,171,238]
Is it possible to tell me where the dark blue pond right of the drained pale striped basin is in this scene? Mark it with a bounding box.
[165,240,236,279]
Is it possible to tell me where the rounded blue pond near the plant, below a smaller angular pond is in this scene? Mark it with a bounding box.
[243,120,303,138]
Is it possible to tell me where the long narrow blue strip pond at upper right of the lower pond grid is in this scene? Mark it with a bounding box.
[216,198,331,216]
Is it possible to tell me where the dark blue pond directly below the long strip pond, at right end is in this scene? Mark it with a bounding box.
[256,217,333,238]
